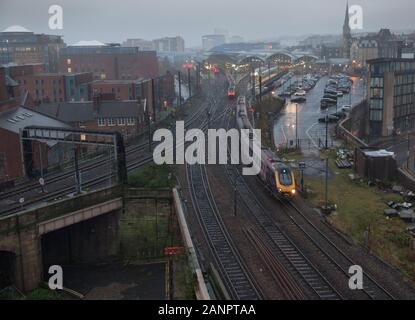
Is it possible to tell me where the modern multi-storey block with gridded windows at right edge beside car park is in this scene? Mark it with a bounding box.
[367,58,415,137]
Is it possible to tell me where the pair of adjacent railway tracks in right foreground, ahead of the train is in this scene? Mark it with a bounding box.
[226,105,395,300]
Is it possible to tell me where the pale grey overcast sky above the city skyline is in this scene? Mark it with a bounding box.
[0,0,415,46]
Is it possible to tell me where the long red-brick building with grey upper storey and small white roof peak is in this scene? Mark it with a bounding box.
[59,45,159,80]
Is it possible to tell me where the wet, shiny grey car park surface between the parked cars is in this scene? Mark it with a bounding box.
[274,76,364,155]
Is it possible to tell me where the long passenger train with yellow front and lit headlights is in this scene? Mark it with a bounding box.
[236,96,297,198]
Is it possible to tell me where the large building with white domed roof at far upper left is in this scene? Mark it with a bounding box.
[0,26,65,72]
